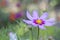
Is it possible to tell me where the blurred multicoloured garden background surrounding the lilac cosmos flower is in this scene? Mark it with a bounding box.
[0,0,60,40]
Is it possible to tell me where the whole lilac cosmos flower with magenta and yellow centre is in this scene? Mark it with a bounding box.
[23,10,55,29]
